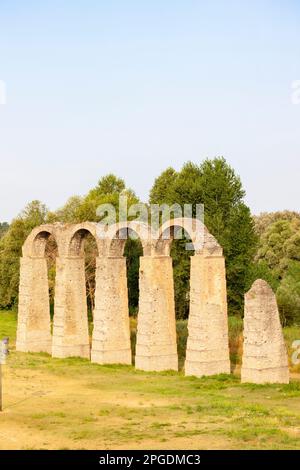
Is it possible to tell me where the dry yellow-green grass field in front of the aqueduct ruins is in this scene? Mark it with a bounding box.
[0,312,300,449]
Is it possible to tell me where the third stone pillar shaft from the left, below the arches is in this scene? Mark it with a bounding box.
[91,256,131,364]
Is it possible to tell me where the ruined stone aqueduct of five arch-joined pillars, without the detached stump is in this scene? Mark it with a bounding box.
[17,219,230,376]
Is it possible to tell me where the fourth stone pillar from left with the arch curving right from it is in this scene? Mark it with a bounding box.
[136,218,202,371]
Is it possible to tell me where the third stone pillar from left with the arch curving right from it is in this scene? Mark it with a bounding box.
[91,221,152,364]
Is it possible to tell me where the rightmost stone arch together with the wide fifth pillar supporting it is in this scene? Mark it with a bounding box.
[155,218,230,376]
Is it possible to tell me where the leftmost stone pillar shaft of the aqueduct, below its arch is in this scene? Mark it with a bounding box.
[16,257,52,354]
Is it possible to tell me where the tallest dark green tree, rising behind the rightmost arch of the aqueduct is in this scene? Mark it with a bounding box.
[150,158,257,318]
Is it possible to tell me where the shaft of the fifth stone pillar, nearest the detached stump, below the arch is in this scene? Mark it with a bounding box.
[185,253,230,377]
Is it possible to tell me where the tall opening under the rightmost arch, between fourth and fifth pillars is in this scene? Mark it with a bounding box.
[157,225,195,370]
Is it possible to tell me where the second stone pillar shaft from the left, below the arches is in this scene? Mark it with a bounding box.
[52,256,90,358]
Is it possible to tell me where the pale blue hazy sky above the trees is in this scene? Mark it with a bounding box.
[0,0,300,221]
